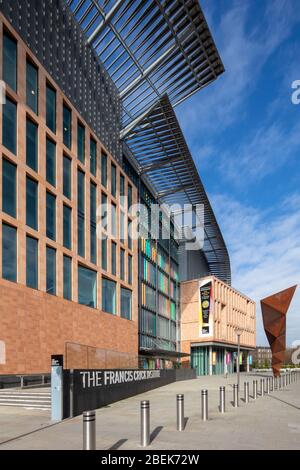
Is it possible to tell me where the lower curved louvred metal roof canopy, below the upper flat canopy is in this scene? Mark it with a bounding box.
[126,95,231,284]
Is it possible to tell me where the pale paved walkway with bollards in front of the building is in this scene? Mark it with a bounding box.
[0,375,300,450]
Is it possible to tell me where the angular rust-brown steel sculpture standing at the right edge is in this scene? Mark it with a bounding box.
[260,286,297,377]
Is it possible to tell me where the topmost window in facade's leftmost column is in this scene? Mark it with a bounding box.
[3,32,18,91]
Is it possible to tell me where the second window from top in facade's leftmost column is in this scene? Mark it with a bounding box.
[2,96,17,155]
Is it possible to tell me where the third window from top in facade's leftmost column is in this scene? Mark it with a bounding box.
[2,159,17,217]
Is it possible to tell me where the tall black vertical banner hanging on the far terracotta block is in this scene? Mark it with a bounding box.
[199,281,213,337]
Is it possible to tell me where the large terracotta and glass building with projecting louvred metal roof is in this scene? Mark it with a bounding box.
[0,0,231,373]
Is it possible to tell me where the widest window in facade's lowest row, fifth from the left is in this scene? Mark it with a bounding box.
[78,265,97,308]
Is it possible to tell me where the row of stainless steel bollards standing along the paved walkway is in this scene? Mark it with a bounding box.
[83,371,300,450]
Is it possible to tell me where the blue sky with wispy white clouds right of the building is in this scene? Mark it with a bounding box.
[177,0,300,344]
